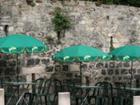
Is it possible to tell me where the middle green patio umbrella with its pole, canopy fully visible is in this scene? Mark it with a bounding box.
[53,45,107,84]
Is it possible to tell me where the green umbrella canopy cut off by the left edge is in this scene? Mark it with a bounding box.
[0,34,48,54]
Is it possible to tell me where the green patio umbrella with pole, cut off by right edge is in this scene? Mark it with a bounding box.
[110,45,140,86]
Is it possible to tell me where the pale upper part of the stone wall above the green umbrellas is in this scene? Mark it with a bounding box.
[0,0,140,47]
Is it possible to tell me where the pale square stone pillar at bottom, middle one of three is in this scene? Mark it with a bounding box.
[58,92,70,105]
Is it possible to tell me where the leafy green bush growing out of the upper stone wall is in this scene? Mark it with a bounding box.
[52,8,71,32]
